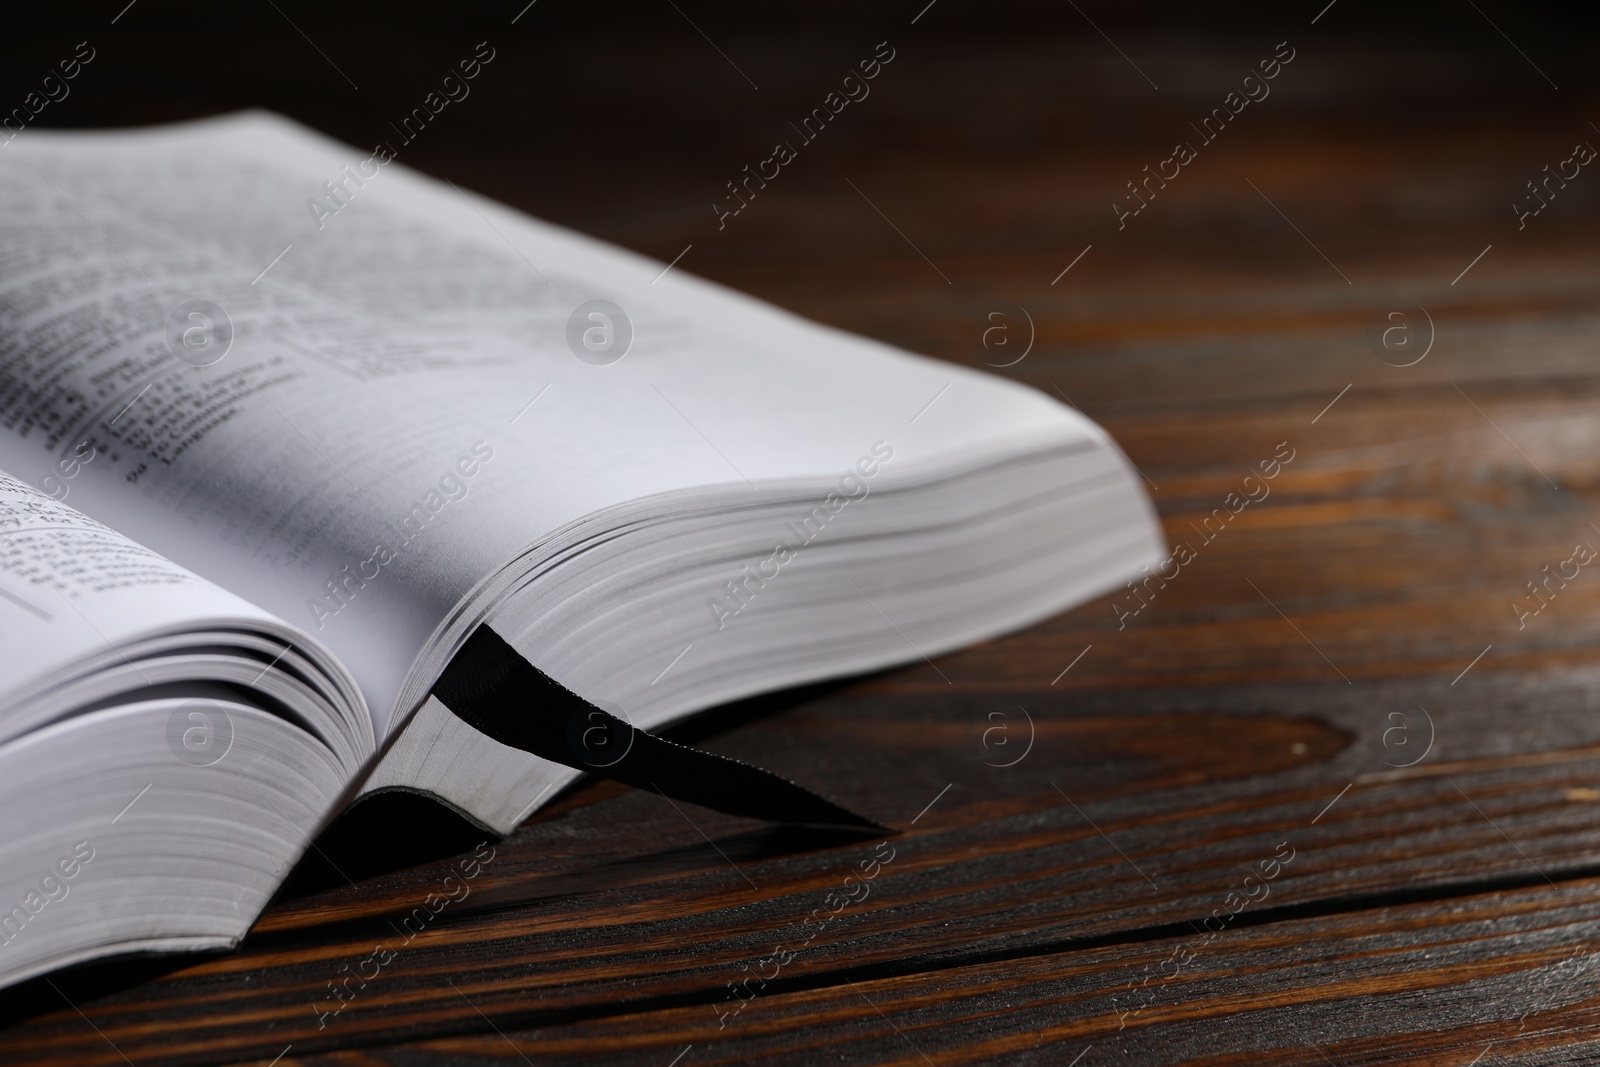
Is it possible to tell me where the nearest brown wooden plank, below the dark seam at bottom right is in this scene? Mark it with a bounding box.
[275,876,1600,1067]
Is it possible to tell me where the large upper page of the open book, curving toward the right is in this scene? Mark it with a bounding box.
[0,114,1099,734]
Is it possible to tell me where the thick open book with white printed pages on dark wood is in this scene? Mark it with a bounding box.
[0,112,1163,984]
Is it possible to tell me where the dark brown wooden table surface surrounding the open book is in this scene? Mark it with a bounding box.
[0,0,1600,1067]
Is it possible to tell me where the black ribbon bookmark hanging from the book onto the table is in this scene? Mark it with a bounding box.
[434,624,888,830]
